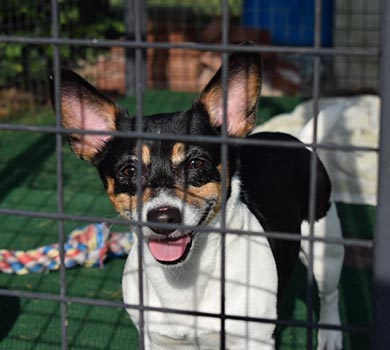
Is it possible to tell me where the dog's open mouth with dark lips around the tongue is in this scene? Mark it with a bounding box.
[148,235,192,264]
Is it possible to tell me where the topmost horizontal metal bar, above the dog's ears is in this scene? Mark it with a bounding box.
[0,35,380,56]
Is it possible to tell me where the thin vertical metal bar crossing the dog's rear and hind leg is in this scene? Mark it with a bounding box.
[306,0,322,350]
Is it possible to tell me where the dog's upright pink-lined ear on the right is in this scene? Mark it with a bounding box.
[199,52,261,137]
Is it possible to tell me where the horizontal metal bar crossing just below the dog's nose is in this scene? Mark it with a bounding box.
[0,208,373,248]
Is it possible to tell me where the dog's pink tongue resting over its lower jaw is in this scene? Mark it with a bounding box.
[149,237,191,262]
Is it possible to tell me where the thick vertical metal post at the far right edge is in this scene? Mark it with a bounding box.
[373,1,390,350]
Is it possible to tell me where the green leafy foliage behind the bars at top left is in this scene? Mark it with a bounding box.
[0,0,125,99]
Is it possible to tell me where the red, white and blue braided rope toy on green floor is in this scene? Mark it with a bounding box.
[0,223,133,275]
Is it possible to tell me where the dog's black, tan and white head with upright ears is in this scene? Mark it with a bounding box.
[52,49,261,264]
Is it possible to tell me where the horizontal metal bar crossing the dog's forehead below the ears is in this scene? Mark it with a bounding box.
[0,124,379,152]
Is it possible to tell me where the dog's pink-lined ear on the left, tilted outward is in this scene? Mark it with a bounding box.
[50,69,117,161]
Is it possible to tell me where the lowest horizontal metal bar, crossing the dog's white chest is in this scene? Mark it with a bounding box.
[0,288,370,333]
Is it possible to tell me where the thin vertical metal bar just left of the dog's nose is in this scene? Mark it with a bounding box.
[134,0,145,350]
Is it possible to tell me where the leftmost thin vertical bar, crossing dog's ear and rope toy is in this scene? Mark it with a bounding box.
[51,0,68,350]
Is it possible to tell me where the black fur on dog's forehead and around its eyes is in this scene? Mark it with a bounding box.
[96,104,236,202]
